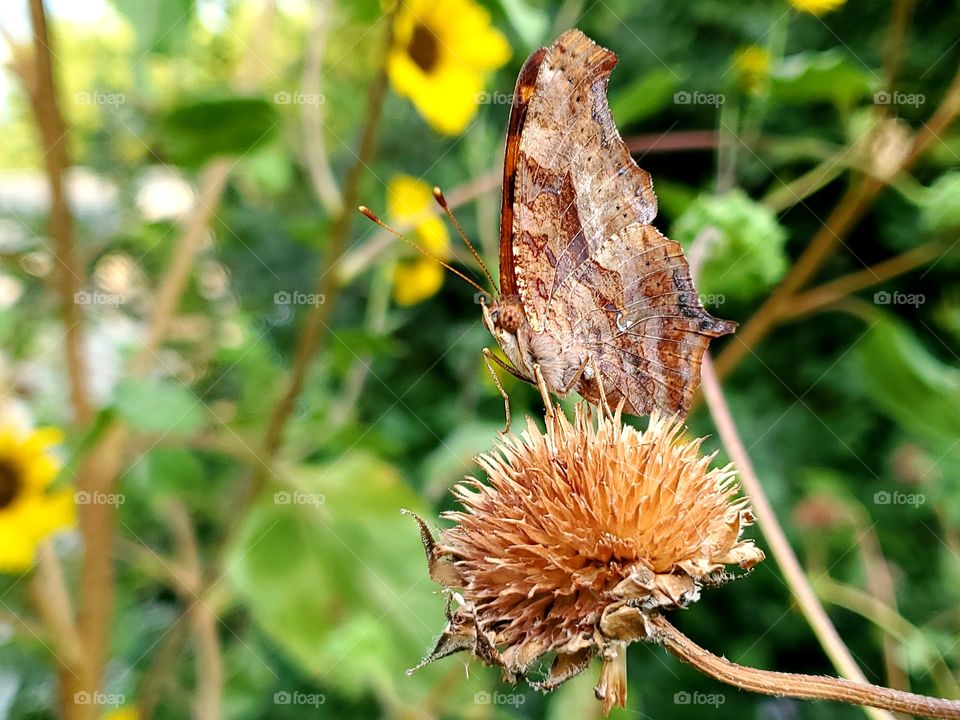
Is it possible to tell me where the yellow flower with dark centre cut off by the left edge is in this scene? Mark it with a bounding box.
[0,427,74,572]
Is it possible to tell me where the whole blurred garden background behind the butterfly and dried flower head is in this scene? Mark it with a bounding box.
[0,0,960,720]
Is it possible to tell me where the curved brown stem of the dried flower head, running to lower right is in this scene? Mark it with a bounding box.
[647,614,960,718]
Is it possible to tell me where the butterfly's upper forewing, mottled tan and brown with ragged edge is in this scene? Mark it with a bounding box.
[510,30,657,331]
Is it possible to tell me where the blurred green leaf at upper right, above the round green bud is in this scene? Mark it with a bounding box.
[770,50,879,108]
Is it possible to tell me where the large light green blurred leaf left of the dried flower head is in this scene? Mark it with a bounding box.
[228,452,488,707]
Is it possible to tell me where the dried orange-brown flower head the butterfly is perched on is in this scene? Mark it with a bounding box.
[406,407,763,711]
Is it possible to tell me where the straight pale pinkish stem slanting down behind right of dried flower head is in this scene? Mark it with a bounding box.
[701,353,892,720]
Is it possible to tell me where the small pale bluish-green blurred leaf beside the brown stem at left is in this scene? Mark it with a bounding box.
[113,378,204,434]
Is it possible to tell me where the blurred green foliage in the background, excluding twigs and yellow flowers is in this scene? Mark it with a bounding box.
[0,0,960,720]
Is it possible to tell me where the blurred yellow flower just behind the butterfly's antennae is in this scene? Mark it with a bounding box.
[387,175,450,305]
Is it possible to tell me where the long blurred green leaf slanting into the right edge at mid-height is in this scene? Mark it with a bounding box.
[856,315,960,447]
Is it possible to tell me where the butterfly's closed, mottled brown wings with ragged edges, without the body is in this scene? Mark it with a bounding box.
[501,30,735,414]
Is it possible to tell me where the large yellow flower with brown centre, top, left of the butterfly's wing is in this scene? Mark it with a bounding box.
[387,0,510,135]
